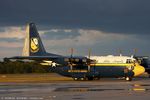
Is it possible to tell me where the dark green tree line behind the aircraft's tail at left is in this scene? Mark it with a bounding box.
[0,61,52,74]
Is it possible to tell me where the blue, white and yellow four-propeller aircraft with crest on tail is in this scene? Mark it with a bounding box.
[7,23,145,81]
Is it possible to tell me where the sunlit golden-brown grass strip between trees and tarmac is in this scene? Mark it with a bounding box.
[0,73,72,83]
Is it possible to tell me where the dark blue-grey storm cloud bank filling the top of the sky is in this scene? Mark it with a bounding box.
[0,0,150,34]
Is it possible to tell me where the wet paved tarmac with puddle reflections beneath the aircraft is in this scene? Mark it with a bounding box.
[0,78,150,100]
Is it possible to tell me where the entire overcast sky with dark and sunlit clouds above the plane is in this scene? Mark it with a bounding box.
[0,0,150,57]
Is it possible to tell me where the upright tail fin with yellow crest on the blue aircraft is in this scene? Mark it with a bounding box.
[22,23,46,56]
